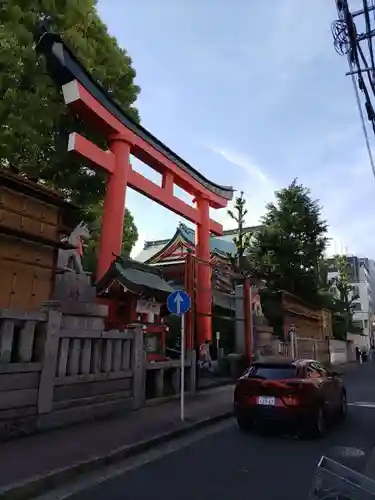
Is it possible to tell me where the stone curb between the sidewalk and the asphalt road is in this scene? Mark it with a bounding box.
[0,411,233,500]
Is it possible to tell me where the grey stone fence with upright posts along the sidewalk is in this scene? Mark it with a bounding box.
[0,302,195,439]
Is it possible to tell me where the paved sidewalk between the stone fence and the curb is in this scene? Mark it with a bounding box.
[0,386,233,498]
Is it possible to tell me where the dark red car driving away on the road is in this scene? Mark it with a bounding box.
[234,359,347,436]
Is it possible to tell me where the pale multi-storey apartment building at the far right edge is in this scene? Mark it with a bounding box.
[328,256,375,340]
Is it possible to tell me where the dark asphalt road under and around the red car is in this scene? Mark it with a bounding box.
[65,362,375,500]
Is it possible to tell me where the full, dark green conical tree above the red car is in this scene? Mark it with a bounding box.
[249,180,327,300]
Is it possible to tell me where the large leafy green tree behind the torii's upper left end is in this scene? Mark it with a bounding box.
[0,0,139,207]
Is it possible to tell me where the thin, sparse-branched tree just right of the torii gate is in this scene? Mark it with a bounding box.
[228,191,252,271]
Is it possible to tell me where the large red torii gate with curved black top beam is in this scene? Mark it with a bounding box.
[37,27,234,342]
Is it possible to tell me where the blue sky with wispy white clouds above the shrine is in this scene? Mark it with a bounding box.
[98,0,375,258]
